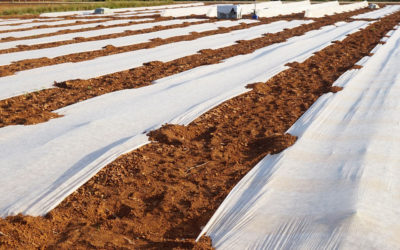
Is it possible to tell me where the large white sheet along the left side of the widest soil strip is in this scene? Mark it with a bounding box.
[0,22,365,216]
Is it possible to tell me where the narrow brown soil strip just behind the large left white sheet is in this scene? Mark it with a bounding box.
[0,11,370,127]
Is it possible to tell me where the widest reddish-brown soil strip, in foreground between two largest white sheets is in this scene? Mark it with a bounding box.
[0,8,400,249]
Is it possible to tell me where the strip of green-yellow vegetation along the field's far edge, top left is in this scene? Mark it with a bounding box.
[0,0,173,16]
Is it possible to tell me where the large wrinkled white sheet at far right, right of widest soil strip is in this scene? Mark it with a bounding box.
[198,25,400,250]
